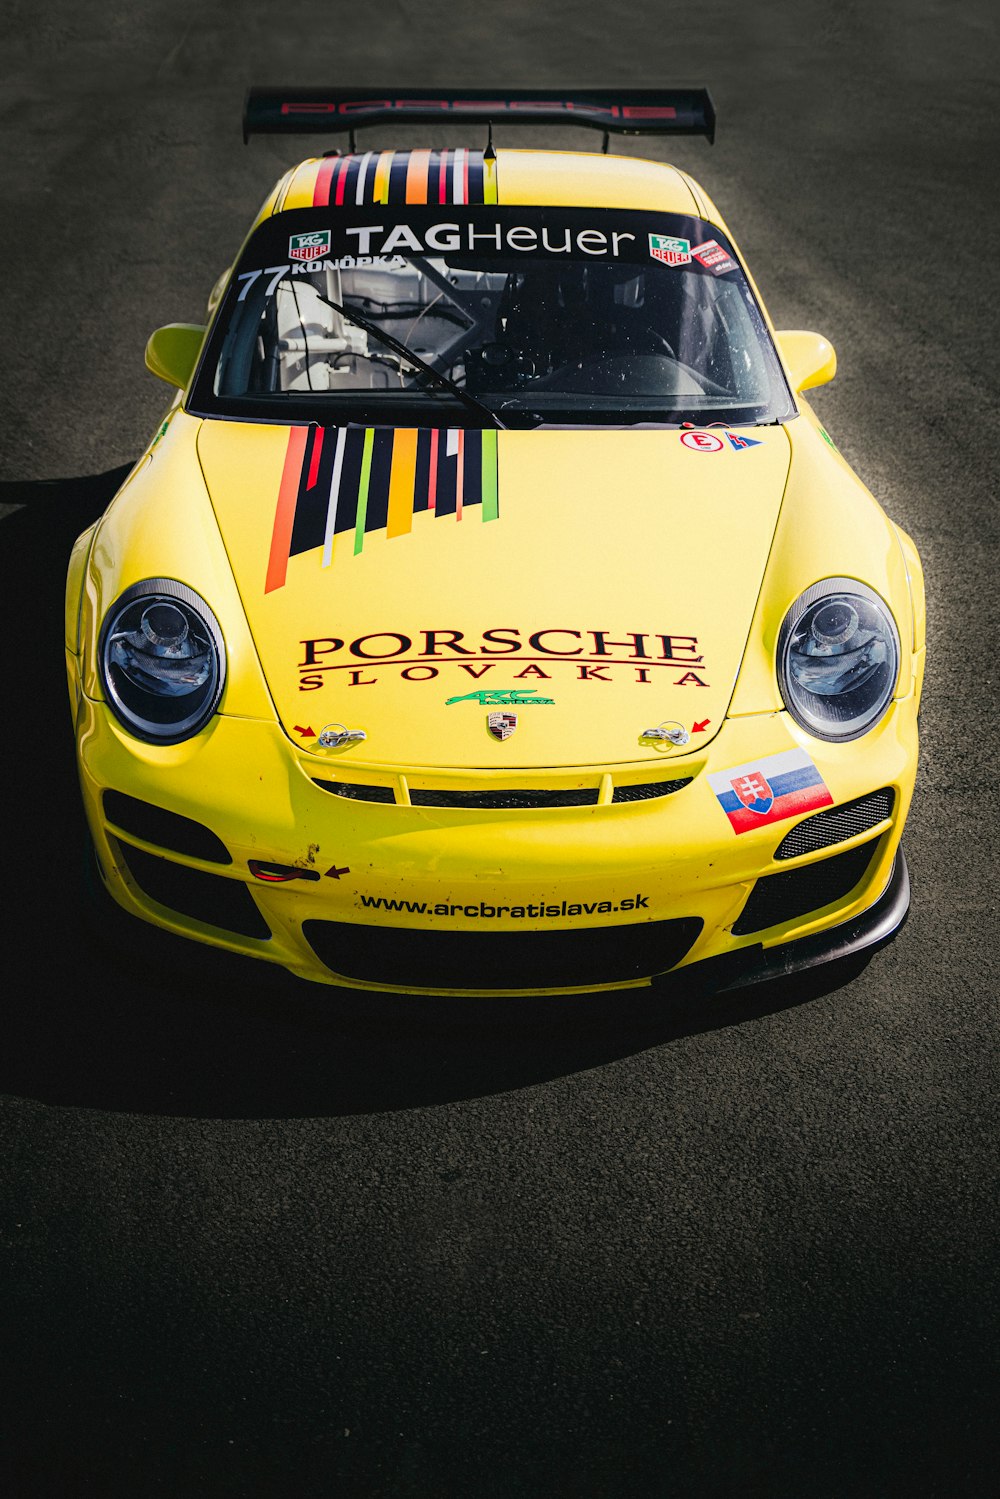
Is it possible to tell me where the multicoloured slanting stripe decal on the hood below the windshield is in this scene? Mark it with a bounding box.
[264,427,499,594]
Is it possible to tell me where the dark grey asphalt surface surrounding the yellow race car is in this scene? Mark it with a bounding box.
[0,0,1000,1499]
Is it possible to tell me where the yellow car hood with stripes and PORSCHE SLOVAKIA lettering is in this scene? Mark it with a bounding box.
[198,421,790,769]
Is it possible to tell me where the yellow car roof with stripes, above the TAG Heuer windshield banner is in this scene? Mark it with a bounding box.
[256,150,721,223]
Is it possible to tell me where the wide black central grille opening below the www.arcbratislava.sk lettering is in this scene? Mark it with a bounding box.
[303,916,702,991]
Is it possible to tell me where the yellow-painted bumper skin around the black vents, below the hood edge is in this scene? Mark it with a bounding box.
[70,686,916,994]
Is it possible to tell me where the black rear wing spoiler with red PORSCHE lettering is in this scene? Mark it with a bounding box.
[243,87,715,147]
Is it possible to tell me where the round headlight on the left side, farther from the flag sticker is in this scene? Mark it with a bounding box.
[99,577,226,745]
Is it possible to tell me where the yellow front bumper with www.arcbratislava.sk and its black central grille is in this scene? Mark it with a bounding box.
[69,671,916,995]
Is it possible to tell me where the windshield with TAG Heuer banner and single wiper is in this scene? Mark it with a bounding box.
[189,205,795,427]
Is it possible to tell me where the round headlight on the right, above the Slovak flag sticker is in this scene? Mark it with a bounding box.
[778,577,900,739]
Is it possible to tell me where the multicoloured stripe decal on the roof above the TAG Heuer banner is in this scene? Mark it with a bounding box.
[312,147,496,208]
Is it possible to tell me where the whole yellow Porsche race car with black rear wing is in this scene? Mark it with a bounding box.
[66,90,924,995]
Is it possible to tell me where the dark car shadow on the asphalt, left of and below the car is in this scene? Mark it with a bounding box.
[0,465,881,1118]
